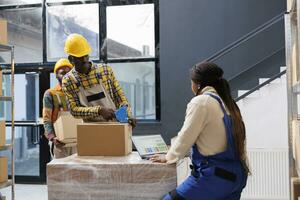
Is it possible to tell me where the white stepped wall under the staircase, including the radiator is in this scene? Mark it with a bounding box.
[237,67,289,200]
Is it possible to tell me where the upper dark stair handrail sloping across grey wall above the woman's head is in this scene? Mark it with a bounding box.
[206,12,285,62]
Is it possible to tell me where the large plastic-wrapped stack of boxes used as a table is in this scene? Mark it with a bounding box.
[47,152,177,200]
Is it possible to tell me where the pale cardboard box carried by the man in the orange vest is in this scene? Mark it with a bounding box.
[54,112,82,143]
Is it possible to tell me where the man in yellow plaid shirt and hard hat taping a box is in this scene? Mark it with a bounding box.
[62,33,136,127]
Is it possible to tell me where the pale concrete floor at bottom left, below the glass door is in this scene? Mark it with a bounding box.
[0,184,48,200]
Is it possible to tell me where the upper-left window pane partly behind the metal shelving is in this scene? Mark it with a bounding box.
[0,8,43,63]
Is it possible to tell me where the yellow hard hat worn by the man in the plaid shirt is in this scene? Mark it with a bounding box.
[65,33,92,57]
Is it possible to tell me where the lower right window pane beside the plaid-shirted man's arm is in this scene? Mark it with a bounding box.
[109,62,156,119]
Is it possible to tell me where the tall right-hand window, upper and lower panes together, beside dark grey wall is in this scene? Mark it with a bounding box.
[103,4,158,120]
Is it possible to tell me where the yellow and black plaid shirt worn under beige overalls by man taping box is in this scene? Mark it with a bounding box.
[62,63,131,119]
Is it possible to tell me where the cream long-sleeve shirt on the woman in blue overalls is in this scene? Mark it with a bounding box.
[166,87,228,164]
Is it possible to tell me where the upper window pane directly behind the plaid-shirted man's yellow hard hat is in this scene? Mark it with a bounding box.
[47,4,99,61]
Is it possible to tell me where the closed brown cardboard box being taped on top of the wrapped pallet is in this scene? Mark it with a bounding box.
[77,123,132,156]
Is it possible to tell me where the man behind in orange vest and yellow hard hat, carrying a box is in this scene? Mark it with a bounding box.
[43,58,76,158]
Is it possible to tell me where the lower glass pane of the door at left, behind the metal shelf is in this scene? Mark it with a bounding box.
[0,126,40,176]
